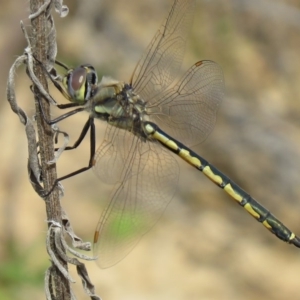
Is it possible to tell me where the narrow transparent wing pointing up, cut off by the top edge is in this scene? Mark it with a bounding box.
[131,0,195,102]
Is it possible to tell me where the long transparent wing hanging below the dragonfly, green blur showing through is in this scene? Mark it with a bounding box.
[94,135,179,268]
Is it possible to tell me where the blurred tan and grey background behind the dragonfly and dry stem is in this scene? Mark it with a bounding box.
[0,0,300,300]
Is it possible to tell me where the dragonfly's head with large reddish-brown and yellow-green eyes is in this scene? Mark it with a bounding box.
[62,64,98,104]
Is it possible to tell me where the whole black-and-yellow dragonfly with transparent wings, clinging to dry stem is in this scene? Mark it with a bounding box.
[42,0,300,268]
